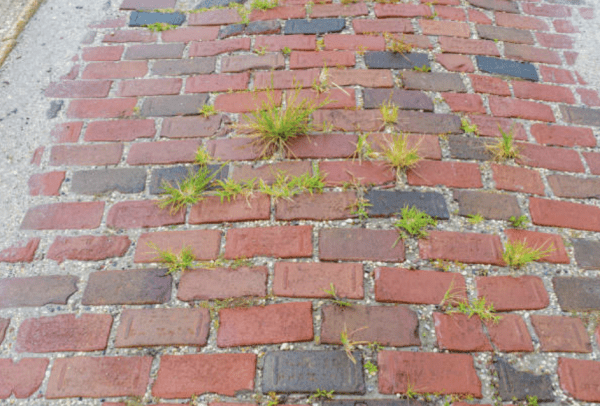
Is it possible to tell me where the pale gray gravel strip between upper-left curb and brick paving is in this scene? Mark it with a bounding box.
[0,0,120,250]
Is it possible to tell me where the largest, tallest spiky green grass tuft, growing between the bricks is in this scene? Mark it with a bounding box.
[243,88,329,156]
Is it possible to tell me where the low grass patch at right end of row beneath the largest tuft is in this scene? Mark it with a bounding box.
[258,169,325,200]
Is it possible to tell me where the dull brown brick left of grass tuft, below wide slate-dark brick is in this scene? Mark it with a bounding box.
[319,228,404,262]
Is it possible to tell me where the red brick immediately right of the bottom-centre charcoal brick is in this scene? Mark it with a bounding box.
[377,351,481,397]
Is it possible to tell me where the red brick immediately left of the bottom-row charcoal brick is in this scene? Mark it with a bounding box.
[152,354,256,399]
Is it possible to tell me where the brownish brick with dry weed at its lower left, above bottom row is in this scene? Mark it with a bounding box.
[321,305,421,347]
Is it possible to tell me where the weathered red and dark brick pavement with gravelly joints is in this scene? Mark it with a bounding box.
[0,0,600,406]
